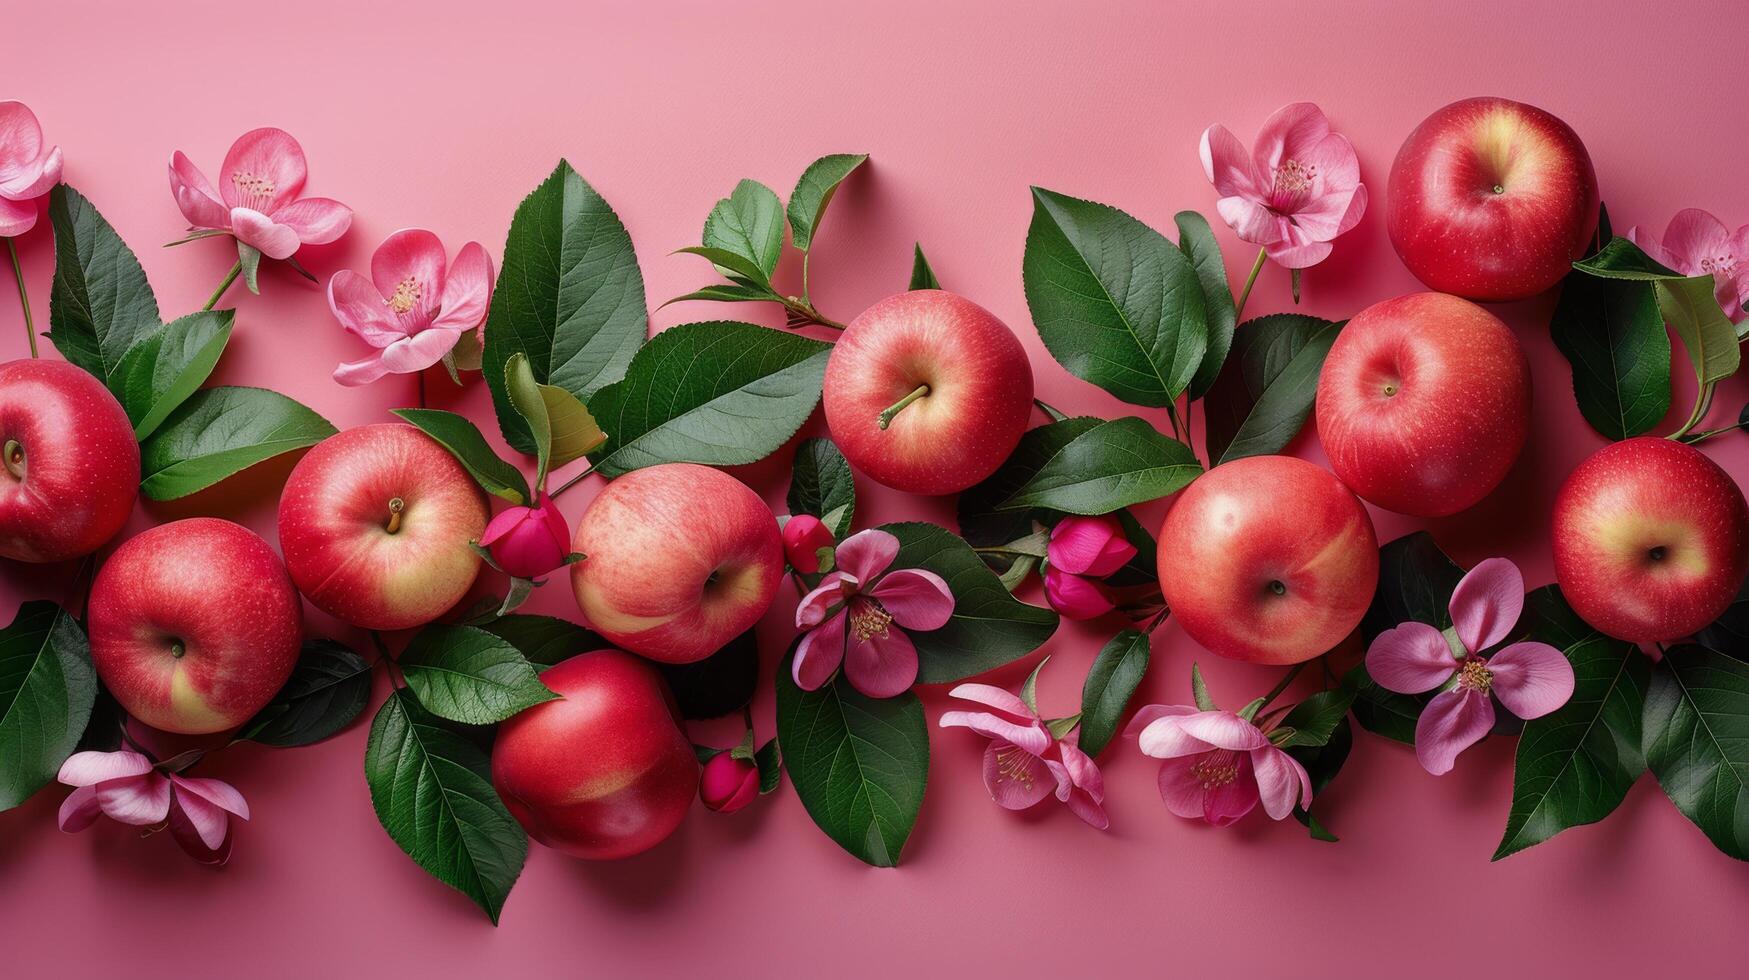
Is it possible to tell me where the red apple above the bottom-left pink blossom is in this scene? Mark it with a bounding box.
[87,518,303,735]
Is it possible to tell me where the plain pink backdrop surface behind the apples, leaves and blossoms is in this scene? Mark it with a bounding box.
[0,0,1749,977]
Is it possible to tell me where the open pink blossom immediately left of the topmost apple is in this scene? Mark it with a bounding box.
[1202,102,1366,270]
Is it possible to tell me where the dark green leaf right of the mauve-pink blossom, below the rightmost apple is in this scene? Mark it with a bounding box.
[1494,586,1651,861]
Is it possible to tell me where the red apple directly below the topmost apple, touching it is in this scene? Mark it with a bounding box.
[1317,292,1530,518]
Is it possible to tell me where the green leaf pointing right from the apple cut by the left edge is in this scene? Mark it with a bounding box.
[140,387,336,501]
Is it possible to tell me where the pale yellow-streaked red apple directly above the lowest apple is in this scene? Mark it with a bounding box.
[570,462,784,663]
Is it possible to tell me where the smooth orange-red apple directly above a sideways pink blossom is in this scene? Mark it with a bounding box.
[1160,457,1378,663]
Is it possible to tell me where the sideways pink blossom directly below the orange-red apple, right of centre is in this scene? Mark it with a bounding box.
[1123,705,1312,826]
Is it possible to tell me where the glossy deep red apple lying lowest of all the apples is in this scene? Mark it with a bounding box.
[491,649,698,861]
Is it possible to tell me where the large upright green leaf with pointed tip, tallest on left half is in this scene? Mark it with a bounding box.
[481,161,649,455]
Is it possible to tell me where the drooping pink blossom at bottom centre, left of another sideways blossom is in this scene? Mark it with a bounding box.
[939,684,1111,830]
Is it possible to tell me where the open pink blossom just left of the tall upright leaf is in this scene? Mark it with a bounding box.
[329,228,491,387]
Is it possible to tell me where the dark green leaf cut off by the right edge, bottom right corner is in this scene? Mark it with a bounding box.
[1644,644,1749,861]
